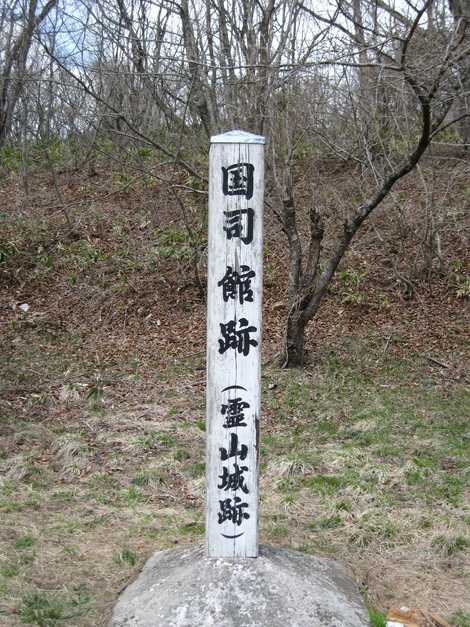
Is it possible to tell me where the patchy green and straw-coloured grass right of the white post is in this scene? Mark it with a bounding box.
[262,345,470,612]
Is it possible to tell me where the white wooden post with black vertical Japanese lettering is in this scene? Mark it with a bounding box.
[206,131,264,557]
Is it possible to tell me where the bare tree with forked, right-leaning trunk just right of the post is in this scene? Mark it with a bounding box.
[278,0,470,366]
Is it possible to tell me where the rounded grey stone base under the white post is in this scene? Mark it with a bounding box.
[110,545,370,627]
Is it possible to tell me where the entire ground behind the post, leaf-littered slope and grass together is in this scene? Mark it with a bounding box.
[0,155,470,627]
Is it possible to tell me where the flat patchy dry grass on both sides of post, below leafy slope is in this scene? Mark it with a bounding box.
[0,312,470,627]
